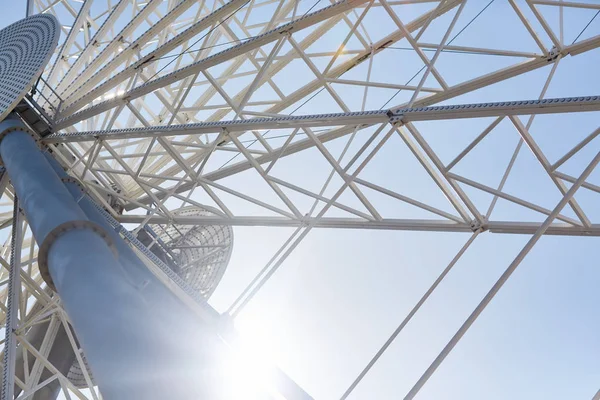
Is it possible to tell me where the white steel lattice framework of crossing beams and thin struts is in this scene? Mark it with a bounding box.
[0,0,600,399]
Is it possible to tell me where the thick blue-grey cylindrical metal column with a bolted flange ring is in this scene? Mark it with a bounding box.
[0,120,220,400]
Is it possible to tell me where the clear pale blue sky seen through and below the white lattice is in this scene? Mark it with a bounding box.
[2,0,600,400]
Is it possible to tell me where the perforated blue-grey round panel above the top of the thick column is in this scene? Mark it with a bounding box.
[0,14,60,121]
